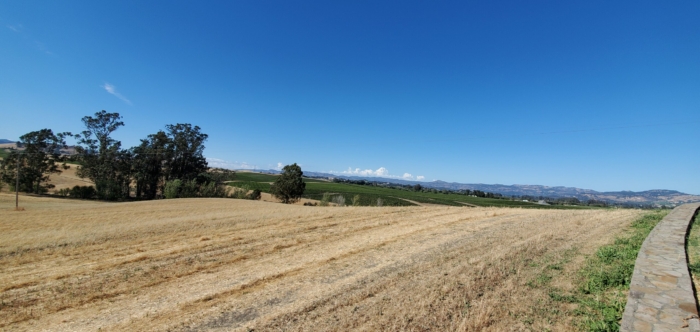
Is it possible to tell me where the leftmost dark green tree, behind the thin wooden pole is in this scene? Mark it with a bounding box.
[2,129,71,194]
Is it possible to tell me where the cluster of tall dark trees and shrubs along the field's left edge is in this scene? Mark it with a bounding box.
[1,110,235,200]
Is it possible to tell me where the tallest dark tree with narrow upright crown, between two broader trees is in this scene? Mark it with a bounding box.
[76,110,132,200]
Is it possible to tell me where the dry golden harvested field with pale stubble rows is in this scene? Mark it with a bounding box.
[0,194,640,331]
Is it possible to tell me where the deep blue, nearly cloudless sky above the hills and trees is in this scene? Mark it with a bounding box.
[0,1,700,194]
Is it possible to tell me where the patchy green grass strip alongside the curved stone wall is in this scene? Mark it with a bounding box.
[523,210,669,331]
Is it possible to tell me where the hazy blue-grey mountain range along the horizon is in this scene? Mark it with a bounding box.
[249,170,700,206]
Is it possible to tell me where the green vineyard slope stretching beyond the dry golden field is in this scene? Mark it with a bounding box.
[229,172,590,209]
